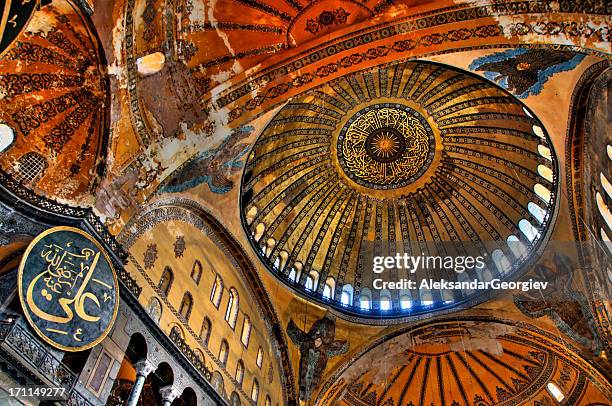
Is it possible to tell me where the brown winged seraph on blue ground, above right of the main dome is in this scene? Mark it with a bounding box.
[470,48,585,99]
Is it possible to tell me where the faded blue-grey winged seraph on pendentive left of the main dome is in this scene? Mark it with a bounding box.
[158,126,254,194]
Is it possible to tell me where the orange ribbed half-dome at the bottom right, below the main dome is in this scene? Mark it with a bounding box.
[317,320,612,406]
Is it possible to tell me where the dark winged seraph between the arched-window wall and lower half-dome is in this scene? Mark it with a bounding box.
[287,315,348,401]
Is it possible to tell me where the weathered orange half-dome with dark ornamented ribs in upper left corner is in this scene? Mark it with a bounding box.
[0,0,109,201]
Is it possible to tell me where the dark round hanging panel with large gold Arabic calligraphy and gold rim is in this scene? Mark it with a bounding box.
[17,227,119,351]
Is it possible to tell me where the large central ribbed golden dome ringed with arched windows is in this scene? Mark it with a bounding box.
[241,61,558,317]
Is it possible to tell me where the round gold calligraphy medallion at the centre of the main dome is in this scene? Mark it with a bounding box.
[337,103,435,189]
